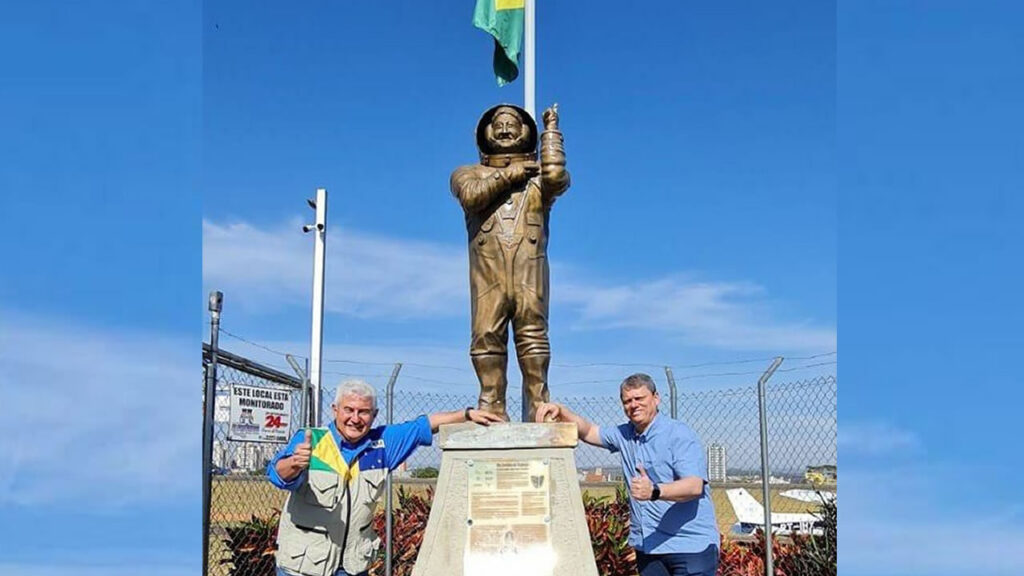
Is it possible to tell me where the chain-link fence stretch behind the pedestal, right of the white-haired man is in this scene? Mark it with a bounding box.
[368,376,837,486]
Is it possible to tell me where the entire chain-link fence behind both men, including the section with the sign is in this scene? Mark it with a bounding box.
[203,344,837,576]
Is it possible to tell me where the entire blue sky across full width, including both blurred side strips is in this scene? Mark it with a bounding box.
[0,0,1024,576]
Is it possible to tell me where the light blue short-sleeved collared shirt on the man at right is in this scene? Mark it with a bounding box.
[600,414,719,554]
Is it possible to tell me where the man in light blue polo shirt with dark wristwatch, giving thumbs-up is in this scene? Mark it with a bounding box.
[537,374,719,576]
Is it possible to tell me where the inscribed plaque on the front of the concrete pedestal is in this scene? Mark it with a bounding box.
[464,459,554,576]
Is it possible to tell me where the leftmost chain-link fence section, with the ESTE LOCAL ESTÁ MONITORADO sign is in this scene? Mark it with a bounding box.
[203,343,303,576]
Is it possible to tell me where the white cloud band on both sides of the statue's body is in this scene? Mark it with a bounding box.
[203,215,836,351]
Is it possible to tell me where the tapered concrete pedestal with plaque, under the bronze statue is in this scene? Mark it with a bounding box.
[413,422,598,576]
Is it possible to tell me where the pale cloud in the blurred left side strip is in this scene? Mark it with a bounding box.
[0,314,195,508]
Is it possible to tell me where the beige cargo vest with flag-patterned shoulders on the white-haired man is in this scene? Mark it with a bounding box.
[276,428,388,576]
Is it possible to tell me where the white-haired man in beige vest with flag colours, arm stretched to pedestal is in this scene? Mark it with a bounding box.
[266,380,501,576]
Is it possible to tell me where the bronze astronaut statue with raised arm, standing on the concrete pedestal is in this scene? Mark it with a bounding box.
[452,105,569,422]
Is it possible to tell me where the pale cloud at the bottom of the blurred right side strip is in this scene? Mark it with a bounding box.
[839,463,1024,576]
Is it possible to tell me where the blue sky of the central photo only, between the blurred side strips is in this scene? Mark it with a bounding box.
[202,2,836,366]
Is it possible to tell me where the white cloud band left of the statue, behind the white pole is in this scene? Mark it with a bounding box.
[203,220,468,319]
